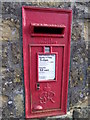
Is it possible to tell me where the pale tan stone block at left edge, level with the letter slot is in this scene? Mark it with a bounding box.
[0,19,20,40]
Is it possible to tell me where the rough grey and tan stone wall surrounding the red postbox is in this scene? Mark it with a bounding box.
[0,0,90,120]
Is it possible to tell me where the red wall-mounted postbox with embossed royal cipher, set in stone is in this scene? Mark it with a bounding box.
[22,6,72,118]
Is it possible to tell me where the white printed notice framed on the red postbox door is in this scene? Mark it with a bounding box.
[38,54,55,81]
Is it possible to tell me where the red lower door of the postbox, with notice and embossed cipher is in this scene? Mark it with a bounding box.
[29,44,64,112]
